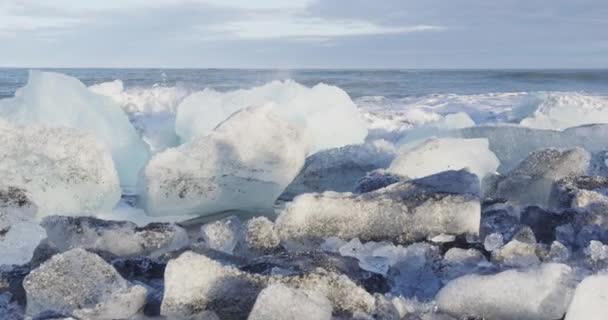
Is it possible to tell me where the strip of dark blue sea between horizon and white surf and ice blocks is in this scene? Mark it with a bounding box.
[0,69,608,98]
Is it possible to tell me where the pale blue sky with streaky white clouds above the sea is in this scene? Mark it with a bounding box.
[0,0,608,69]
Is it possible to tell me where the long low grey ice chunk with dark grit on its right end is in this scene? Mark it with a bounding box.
[42,216,189,257]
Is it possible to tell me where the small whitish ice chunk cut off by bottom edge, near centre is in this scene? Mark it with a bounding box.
[247,284,332,320]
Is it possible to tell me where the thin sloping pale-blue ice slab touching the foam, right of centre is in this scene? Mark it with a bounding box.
[397,112,475,149]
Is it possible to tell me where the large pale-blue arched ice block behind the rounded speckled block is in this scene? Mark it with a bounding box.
[176,80,367,152]
